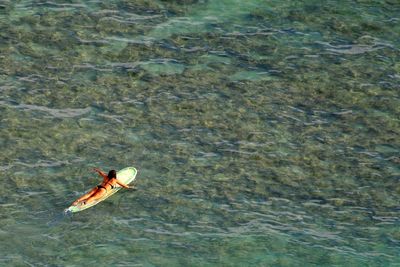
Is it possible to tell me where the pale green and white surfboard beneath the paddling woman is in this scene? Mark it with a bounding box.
[64,167,137,213]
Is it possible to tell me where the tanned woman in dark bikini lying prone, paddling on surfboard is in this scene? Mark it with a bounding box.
[72,168,134,206]
